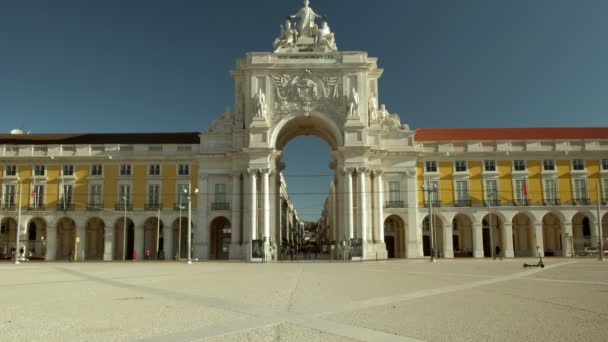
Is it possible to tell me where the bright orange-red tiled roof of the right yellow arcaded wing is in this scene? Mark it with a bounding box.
[414,127,608,141]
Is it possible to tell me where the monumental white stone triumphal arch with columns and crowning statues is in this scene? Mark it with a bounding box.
[194,1,420,259]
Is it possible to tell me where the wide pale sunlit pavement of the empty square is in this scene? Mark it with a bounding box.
[0,258,608,341]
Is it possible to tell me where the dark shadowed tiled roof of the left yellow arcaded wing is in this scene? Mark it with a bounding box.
[0,132,200,145]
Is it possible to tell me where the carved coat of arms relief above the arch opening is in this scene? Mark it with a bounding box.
[269,70,347,124]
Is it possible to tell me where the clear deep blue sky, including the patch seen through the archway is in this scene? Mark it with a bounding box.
[0,0,608,219]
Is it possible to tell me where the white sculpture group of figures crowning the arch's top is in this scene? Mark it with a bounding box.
[272,0,338,52]
